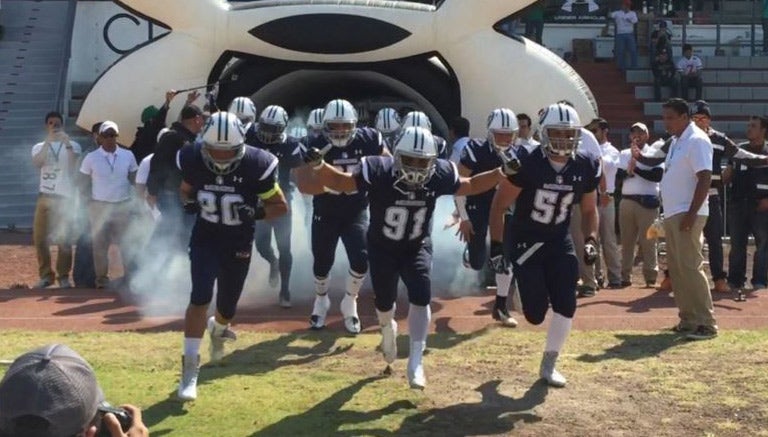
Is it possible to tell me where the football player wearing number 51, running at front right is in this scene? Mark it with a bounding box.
[490,104,601,387]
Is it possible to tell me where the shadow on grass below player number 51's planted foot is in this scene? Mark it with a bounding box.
[391,380,549,437]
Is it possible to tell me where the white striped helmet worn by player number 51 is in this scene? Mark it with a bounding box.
[539,103,582,156]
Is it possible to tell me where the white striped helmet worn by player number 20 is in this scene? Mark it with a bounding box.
[201,112,245,175]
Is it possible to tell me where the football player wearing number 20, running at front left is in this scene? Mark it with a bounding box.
[178,112,288,400]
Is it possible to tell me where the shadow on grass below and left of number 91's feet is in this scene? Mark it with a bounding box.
[251,377,416,437]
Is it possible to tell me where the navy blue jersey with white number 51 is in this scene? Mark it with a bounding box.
[509,148,600,241]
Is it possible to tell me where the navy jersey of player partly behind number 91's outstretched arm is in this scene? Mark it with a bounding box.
[307,127,384,215]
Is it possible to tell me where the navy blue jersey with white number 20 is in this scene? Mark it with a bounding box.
[179,146,278,243]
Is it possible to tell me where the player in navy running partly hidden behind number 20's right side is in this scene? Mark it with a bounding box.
[245,105,304,308]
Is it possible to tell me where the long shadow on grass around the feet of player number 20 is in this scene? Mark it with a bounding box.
[142,333,352,428]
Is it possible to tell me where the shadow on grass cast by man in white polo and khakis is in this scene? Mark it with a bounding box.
[576,332,685,363]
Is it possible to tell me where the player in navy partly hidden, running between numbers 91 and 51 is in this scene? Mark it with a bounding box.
[456,108,525,327]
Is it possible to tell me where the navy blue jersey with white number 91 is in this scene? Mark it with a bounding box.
[355,156,459,248]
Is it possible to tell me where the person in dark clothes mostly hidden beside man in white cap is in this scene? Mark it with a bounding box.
[72,122,101,288]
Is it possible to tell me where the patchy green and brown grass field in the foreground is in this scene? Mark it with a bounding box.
[0,328,768,437]
